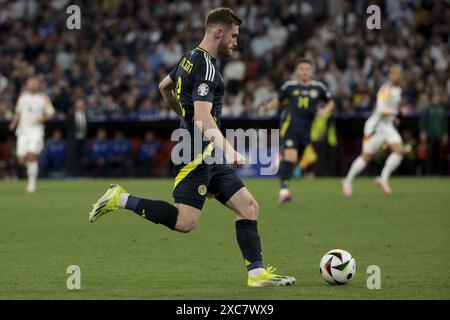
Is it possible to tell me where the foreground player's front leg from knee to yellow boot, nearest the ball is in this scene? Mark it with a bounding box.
[226,187,295,287]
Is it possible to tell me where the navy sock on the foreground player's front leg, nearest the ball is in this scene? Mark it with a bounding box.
[236,219,264,270]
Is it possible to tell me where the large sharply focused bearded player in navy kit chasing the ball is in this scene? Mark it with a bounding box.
[89,8,295,287]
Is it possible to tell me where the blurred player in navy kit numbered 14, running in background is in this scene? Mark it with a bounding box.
[261,58,334,203]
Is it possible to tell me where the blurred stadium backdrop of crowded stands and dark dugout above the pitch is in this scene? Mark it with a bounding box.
[0,0,450,178]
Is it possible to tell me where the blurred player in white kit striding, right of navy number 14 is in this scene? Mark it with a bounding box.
[342,65,404,197]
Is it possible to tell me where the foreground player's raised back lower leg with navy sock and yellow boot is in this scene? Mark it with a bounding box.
[89,184,179,231]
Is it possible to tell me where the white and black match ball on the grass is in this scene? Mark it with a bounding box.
[320,249,356,285]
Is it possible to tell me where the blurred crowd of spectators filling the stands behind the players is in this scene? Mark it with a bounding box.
[0,0,450,120]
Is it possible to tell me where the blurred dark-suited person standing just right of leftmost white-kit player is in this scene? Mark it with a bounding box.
[66,99,88,177]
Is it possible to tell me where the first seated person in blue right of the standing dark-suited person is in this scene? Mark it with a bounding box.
[90,129,111,177]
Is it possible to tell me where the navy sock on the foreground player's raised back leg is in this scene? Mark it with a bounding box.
[125,195,178,230]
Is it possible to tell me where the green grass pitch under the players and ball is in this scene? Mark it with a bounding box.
[0,178,450,299]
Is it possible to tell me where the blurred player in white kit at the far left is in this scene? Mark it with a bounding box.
[9,76,55,193]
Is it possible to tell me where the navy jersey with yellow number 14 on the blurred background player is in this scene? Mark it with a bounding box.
[278,80,331,139]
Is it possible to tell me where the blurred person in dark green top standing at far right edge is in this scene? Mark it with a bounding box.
[420,90,448,175]
